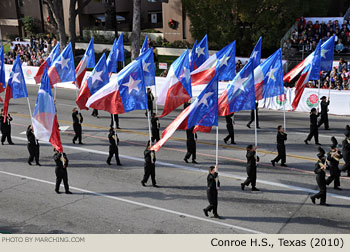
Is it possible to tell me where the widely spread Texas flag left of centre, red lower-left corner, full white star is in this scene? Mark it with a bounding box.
[86,60,148,114]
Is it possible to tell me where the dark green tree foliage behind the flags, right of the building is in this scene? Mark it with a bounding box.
[182,0,331,57]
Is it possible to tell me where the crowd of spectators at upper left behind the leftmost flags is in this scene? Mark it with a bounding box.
[5,35,57,66]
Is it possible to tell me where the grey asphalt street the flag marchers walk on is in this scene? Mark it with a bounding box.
[0,86,350,234]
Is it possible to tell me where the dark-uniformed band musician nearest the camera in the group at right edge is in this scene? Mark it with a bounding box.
[311,158,327,205]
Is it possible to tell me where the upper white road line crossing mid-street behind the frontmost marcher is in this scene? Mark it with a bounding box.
[6,136,350,201]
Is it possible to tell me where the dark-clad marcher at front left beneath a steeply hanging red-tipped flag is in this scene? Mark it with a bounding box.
[53,152,71,194]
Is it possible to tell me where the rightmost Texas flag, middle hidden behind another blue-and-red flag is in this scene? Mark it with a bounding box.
[283,35,335,82]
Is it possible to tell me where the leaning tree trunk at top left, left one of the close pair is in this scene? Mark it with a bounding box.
[44,0,67,48]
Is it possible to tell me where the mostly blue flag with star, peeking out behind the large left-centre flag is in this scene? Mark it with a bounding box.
[136,47,156,87]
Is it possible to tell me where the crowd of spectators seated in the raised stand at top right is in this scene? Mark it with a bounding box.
[283,17,350,54]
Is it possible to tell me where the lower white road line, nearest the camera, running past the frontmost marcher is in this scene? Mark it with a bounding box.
[0,171,263,234]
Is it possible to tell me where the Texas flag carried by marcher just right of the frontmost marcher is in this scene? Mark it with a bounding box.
[219,59,255,116]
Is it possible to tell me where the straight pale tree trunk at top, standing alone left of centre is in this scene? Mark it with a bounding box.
[131,0,141,60]
